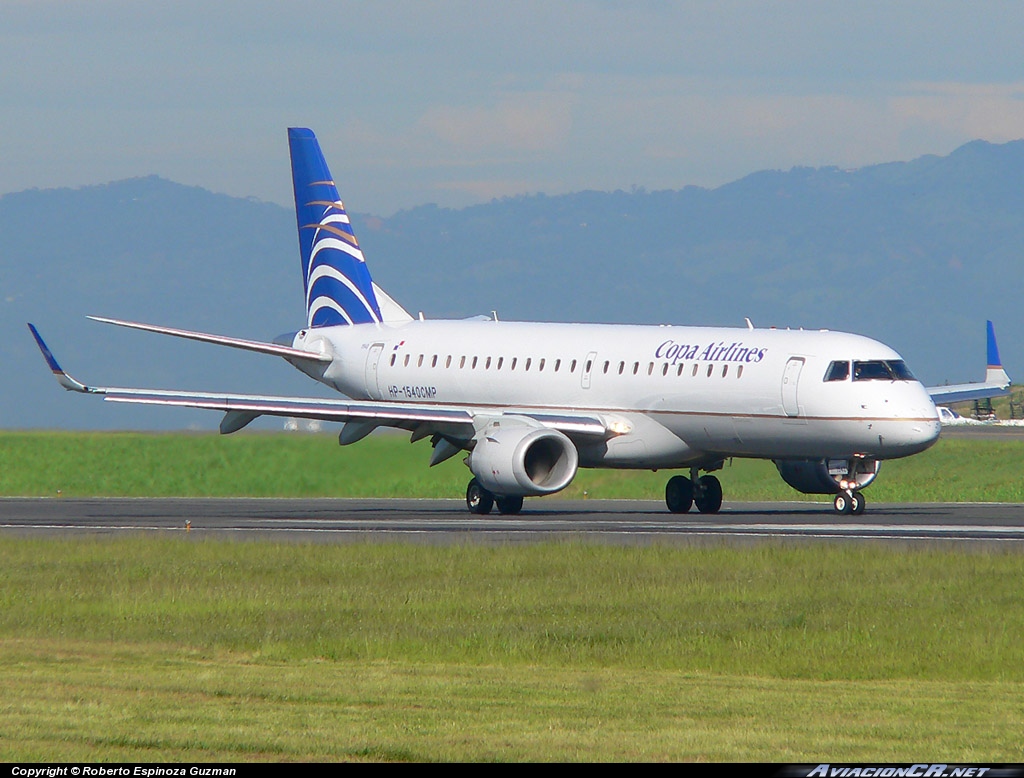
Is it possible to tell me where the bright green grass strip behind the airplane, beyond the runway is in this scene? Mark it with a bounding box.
[6,432,1024,503]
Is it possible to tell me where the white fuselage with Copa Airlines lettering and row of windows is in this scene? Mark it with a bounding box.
[293,320,941,468]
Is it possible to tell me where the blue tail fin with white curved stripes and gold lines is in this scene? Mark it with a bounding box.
[288,127,381,327]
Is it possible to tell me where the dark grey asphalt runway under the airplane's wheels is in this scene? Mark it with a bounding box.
[0,498,1024,549]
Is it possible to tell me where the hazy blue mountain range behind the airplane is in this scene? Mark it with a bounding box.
[0,140,1024,430]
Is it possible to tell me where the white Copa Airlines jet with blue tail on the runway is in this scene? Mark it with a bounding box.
[29,128,1005,515]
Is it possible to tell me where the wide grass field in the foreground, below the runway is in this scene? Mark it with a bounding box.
[0,535,1024,762]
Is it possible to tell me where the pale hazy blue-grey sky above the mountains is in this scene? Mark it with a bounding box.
[0,0,1024,215]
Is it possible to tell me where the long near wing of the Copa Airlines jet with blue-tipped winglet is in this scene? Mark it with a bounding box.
[29,323,613,440]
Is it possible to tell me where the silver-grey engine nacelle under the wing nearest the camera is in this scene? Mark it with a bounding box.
[467,426,580,496]
